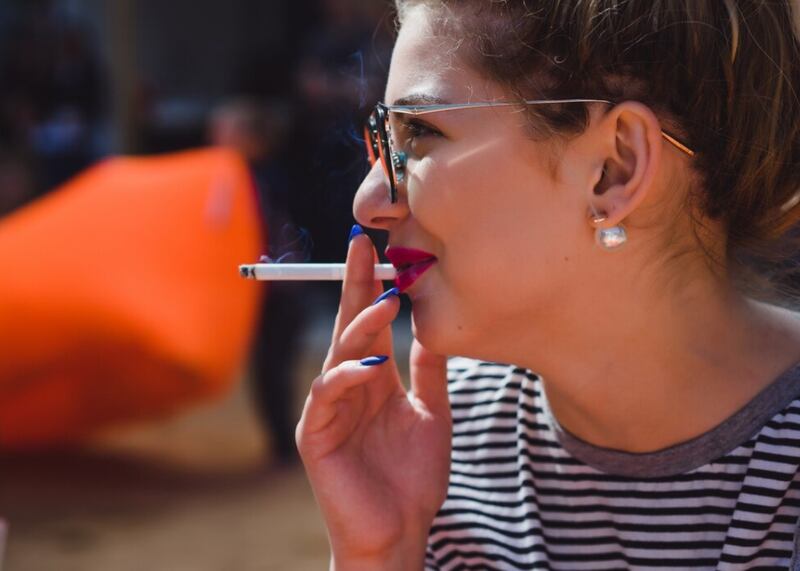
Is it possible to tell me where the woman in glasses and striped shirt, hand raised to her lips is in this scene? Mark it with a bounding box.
[297,0,800,570]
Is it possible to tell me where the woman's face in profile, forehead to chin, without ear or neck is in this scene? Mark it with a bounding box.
[354,7,592,358]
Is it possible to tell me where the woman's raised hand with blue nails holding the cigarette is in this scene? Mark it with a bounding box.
[297,231,452,569]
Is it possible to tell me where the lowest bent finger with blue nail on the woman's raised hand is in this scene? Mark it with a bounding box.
[297,356,388,443]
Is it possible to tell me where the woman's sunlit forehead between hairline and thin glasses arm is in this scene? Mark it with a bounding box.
[386,5,504,104]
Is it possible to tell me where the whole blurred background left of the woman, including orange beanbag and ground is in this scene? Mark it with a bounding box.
[0,0,410,571]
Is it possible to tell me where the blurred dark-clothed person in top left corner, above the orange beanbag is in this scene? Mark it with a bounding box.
[0,2,106,201]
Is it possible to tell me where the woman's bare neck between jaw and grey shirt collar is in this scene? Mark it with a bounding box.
[511,262,800,452]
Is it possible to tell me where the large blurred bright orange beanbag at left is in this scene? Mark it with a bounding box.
[0,146,263,449]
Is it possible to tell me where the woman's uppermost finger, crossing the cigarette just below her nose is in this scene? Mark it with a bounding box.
[333,230,382,340]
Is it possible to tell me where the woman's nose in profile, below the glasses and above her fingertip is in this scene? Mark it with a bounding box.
[353,162,408,230]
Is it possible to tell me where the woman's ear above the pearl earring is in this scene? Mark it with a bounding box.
[589,101,662,228]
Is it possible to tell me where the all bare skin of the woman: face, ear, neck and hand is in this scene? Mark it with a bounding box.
[298,3,800,569]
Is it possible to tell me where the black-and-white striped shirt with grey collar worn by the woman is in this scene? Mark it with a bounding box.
[426,358,800,571]
